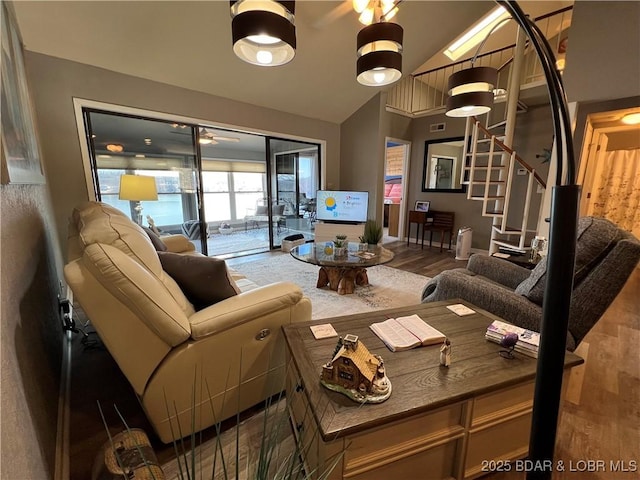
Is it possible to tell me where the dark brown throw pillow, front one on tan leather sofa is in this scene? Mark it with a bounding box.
[158,252,240,310]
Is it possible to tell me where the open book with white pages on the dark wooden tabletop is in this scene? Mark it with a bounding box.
[370,314,446,352]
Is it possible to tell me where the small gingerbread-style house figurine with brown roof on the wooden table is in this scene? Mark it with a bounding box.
[320,334,391,403]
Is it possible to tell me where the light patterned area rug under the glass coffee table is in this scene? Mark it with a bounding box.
[231,253,430,319]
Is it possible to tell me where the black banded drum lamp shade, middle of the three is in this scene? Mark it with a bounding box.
[357,22,404,87]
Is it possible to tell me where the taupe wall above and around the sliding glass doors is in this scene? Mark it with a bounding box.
[26,52,340,258]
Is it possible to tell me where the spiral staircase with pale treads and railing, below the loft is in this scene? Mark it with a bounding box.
[460,117,546,254]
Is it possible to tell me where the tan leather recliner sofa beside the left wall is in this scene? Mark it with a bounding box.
[64,202,311,443]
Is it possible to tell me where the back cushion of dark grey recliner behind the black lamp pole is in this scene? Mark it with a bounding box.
[515,217,621,305]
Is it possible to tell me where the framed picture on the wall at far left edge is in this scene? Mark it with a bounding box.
[0,2,45,183]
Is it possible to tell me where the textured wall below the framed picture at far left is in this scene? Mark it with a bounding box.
[0,185,63,479]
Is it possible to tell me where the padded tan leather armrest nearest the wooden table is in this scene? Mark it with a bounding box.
[189,282,311,340]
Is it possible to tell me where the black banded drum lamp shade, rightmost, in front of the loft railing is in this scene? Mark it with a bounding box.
[446,67,498,117]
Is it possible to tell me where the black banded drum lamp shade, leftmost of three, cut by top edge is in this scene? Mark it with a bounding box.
[230,0,296,66]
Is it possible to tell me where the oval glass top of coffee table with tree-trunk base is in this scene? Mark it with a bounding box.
[291,242,394,268]
